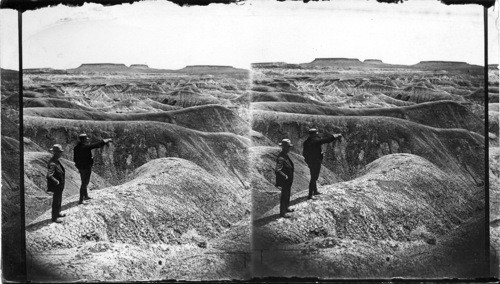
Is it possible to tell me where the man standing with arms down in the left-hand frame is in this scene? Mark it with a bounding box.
[47,144,66,223]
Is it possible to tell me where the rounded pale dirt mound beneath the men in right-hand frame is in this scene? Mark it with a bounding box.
[254,154,484,278]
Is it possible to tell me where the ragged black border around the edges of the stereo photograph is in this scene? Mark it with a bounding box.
[0,0,499,283]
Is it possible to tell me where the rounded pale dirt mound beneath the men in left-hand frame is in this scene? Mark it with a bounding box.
[26,158,249,280]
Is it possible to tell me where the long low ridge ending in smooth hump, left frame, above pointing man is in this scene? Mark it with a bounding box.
[24,105,249,136]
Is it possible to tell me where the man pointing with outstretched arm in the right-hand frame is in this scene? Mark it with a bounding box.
[302,128,342,199]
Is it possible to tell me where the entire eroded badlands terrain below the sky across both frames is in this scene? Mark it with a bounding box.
[2,59,500,280]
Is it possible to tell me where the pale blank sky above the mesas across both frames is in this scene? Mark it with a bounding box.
[0,0,499,70]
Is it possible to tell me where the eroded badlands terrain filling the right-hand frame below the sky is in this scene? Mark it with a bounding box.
[249,59,499,278]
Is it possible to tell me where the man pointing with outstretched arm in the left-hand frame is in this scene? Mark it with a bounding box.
[73,133,112,204]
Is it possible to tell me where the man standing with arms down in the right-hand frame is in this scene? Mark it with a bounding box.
[275,139,294,218]
